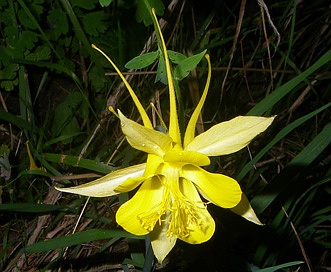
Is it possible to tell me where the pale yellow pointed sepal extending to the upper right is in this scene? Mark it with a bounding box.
[185,116,274,156]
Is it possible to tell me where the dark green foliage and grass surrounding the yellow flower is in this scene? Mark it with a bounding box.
[0,0,331,271]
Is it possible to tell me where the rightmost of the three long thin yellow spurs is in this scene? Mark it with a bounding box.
[184,54,211,148]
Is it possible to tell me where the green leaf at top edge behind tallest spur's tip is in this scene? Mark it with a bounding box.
[136,0,165,26]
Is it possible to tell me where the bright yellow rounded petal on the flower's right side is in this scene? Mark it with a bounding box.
[180,165,242,208]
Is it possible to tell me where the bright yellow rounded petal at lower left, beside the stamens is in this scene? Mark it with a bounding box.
[116,177,164,235]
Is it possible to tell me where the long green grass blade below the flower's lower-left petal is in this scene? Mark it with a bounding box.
[22,229,145,253]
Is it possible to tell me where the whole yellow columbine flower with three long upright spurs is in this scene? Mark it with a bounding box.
[57,9,274,263]
